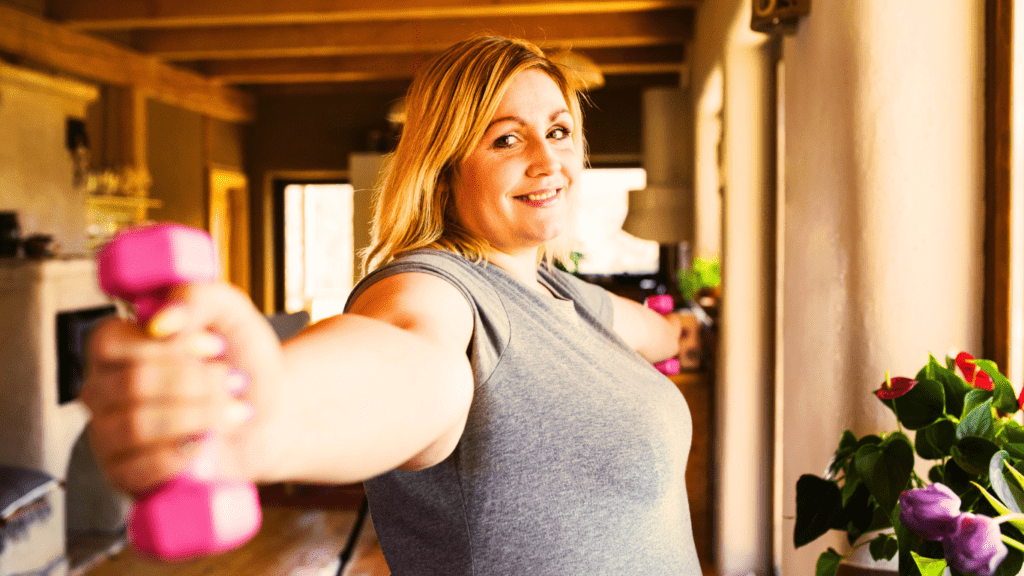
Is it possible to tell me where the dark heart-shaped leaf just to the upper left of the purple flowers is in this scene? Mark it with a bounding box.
[854,433,913,513]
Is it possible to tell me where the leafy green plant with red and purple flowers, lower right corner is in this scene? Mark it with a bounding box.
[794,353,1024,576]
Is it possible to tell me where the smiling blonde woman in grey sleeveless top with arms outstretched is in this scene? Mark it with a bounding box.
[83,37,699,575]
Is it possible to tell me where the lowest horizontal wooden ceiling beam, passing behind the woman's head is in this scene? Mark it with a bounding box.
[202,46,684,84]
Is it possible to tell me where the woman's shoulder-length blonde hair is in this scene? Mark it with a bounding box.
[362,36,586,272]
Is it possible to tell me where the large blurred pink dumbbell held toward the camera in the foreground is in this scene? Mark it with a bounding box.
[98,224,261,560]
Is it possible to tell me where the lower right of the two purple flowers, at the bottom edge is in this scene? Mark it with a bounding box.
[942,512,1007,576]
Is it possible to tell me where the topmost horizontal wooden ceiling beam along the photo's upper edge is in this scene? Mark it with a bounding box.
[47,0,700,31]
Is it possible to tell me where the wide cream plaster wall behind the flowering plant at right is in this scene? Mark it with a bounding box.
[778,0,984,574]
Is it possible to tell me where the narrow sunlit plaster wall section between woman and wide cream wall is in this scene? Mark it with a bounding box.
[690,0,775,576]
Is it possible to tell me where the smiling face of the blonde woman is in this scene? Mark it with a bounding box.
[454,70,583,254]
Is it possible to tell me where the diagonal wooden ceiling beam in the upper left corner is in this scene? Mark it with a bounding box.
[0,5,255,122]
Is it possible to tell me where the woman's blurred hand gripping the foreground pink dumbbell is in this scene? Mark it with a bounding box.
[81,283,283,495]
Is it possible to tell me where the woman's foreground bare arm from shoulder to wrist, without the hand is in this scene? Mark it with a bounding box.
[263,274,473,483]
